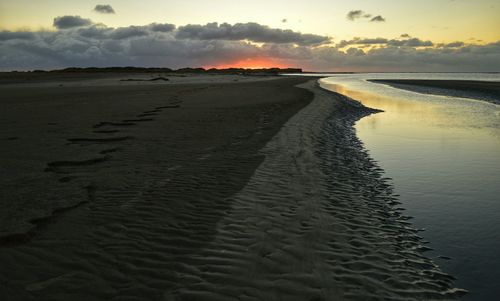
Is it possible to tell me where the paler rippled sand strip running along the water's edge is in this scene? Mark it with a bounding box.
[167,82,465,300]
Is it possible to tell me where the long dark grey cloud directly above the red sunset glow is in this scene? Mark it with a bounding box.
[176,23,330,45]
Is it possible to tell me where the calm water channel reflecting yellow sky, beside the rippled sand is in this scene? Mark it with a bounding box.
[321,73,500,300]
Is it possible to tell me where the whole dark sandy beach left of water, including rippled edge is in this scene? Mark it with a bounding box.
[0,74,464,300]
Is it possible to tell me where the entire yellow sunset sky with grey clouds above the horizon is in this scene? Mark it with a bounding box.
[0,0,500,72]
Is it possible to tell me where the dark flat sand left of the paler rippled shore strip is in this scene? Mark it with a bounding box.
[0,78,312,300]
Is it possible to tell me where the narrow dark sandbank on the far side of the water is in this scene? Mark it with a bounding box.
[370,79,500,104]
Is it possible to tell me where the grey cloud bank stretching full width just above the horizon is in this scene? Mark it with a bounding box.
[0,23,500,72]
